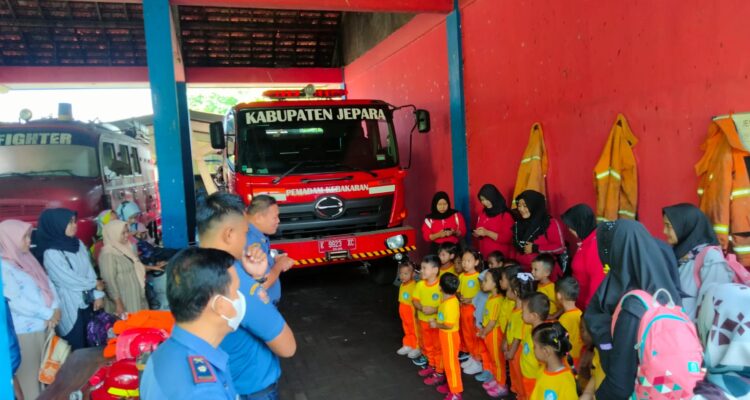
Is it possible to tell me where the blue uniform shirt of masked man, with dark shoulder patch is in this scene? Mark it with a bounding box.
[140,326,237,400]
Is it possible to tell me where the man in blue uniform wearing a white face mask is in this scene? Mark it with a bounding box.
[140,248,250,400]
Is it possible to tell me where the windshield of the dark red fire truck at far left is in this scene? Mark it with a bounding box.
[0,144,99,178]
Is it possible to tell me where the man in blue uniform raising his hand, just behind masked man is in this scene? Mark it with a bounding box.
[196,193,297,400]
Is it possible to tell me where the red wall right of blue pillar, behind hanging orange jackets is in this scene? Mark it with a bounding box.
[462,0,750,234]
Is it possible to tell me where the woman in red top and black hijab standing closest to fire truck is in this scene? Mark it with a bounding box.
[422,192,466,254]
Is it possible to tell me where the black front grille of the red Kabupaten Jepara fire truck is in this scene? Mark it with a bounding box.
[271,195,393,240]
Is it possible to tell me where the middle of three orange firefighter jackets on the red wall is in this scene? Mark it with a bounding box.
[594,114,638,221]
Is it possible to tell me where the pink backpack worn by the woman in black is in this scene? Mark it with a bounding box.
[612,289,704,400]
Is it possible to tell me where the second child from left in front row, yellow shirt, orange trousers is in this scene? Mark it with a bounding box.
[412,255,445,385]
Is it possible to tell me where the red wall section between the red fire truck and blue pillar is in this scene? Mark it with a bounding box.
[344,15,453,255]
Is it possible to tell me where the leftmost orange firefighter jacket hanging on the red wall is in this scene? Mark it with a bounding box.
[513,122,547,203]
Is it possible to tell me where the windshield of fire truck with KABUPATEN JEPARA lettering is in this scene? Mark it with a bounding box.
[235,106,398,175]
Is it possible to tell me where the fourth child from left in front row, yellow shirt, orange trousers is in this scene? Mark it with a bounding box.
[458,249,484,375]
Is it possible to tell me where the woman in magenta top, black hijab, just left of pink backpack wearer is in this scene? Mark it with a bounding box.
[562,204,605,310]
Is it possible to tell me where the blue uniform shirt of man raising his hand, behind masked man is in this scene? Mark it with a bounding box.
[221,262,286,395]
